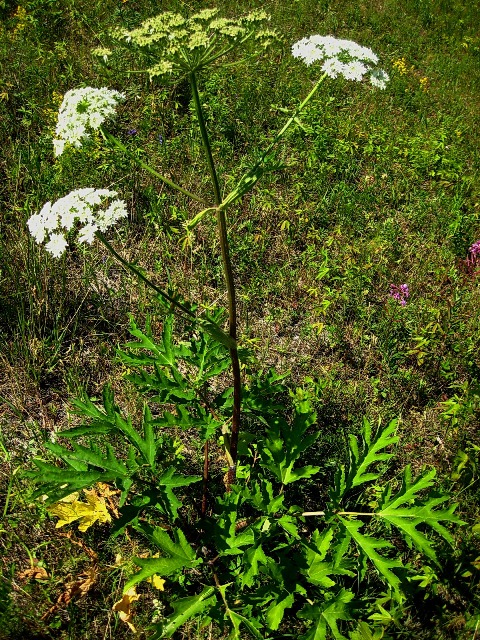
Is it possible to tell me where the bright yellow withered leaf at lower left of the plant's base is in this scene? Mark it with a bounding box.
[47,489,112,531]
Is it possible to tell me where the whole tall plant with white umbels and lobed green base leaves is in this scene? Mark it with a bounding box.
[28,9,459,640]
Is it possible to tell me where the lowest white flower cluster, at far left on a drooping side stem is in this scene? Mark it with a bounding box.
[27,188,128,258]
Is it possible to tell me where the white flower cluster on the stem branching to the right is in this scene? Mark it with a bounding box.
[292,35,389,89]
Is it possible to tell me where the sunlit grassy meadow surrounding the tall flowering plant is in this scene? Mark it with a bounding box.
[0,0,480,639]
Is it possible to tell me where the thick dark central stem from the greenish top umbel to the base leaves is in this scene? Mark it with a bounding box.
[189,72,242,490]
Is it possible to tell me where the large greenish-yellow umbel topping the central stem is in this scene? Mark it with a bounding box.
[93,9,277,79]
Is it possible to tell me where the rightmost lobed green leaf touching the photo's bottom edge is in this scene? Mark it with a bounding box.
[297,589,354,640]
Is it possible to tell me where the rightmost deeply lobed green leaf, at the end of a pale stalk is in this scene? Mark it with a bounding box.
[375,466,465,564]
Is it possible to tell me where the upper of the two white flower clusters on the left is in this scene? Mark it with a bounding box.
[53,87,125,156]
